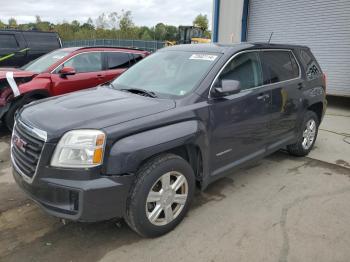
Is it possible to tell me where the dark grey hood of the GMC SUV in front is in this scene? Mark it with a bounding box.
[20,87,175,140]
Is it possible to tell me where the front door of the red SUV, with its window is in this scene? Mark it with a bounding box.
[51,52,105,95]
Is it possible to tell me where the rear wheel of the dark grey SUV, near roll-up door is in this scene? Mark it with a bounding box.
[287,111,319,156]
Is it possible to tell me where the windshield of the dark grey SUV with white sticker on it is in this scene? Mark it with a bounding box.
[112,51,218,97]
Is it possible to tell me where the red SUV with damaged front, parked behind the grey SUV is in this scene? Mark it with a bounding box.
[0,47,149,129]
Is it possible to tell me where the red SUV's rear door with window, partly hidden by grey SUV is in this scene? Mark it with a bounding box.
[103,52,134,82]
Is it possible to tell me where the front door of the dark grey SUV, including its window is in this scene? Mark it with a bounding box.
[210,51,271,175]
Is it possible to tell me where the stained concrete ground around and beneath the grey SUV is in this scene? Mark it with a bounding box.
[0,98,350,262]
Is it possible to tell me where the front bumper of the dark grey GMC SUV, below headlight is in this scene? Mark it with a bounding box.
[13,163,133,222]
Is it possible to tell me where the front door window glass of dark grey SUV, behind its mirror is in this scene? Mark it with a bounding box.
[219,52,262,90]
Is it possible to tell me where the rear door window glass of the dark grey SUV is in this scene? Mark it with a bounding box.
[262,51,299,84]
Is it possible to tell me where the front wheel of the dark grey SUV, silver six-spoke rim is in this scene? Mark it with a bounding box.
[125,154,195,237]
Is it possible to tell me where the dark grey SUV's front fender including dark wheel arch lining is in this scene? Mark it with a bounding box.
[105,120,208,188]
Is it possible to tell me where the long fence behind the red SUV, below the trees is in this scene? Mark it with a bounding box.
[62,39,165,52]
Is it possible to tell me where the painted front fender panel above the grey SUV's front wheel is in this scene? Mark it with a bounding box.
[105,120,208,174]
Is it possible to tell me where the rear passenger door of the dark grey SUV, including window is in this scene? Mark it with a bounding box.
[260,50,303,149]
